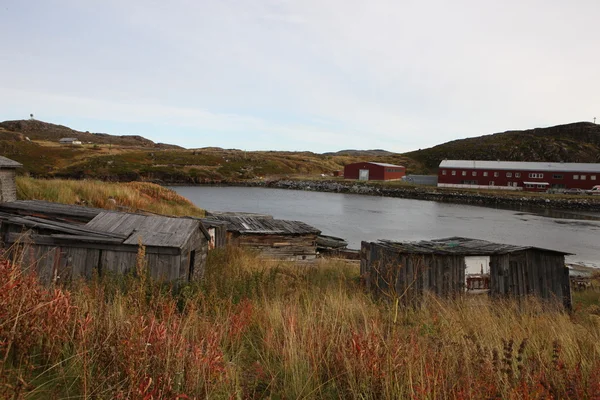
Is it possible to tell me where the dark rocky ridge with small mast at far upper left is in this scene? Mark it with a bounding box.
[0,119,182,149]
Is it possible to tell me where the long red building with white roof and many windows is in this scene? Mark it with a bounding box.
[438,160,600,192]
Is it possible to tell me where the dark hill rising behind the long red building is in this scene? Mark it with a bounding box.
[403,122,600,171]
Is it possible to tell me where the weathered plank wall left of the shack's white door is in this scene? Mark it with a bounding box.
[361,242,465,304]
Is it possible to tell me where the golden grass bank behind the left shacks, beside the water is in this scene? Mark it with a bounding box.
[16,176,204,217]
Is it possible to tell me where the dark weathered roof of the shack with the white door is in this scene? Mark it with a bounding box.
[377,237,572,256]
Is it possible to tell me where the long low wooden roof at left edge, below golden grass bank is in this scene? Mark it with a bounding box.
[0,200,105,223]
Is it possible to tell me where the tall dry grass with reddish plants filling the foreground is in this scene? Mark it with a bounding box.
[0,249,600,399]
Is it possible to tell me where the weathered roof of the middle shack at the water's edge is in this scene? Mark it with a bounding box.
[206,215,321,235]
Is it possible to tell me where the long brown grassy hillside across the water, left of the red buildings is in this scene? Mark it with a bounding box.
[0,121,423,184]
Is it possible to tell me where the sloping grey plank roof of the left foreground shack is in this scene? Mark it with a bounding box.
[85,212,207,248]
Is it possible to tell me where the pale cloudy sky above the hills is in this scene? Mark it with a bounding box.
[0,0,600,152]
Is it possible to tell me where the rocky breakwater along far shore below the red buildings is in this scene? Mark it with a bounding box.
[264,180,600,211]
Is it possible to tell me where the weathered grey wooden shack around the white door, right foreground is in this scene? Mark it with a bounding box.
[361,237,571,309]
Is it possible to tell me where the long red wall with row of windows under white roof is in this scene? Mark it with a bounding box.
[438,168,600,192]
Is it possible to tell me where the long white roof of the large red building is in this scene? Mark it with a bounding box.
[440,160,600,173]
